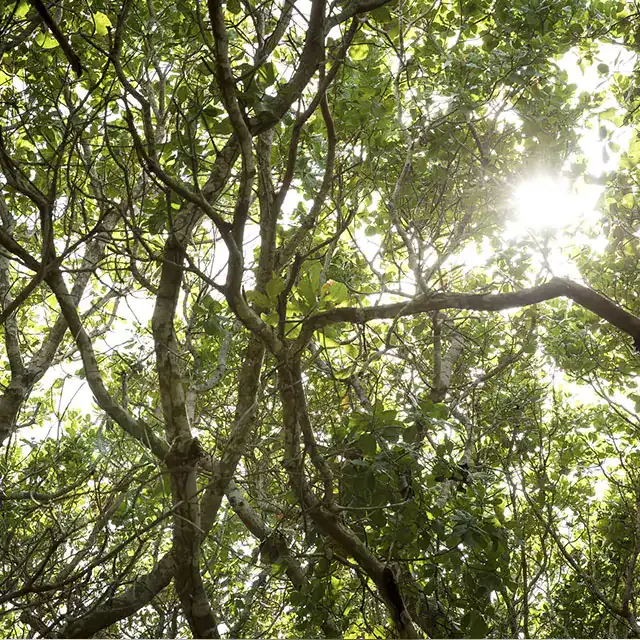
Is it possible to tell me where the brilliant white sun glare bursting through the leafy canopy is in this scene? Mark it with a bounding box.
[512,176,584,231]
